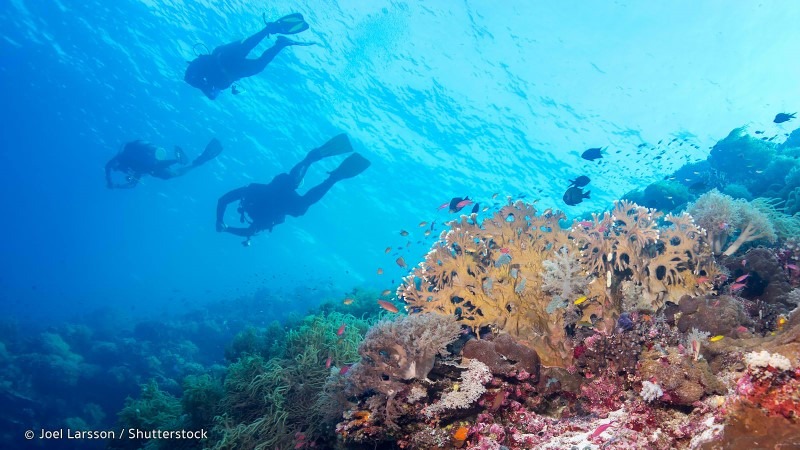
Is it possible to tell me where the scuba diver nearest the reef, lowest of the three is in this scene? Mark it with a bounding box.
[217,134,370,246]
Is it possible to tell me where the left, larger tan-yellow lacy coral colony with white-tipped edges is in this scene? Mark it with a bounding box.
[398,202,572,365]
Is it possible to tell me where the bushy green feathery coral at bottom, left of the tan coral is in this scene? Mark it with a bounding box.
[206,312,370,450]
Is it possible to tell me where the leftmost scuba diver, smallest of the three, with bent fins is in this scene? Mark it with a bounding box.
[106,138,222,189]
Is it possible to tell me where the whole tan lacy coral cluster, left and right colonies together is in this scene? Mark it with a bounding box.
[398,201,717,367]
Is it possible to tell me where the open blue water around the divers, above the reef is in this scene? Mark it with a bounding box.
[0,0,800,446]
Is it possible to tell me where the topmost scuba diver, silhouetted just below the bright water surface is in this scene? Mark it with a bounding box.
[183,13,314,100]
